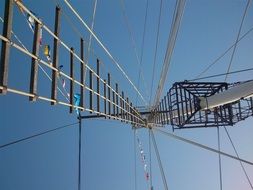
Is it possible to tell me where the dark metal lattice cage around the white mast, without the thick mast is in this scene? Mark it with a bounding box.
[149,81,253,129]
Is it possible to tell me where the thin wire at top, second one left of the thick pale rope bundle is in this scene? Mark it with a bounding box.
[135,0,149,106]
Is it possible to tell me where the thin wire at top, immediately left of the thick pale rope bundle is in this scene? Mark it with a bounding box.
[149,0,163,106]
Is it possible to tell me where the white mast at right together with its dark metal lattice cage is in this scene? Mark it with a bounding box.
[148,80,253,129]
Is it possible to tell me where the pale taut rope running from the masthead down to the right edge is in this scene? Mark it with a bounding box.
[153,128,253,166]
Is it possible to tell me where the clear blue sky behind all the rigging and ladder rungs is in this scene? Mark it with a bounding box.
[0,0,253,190]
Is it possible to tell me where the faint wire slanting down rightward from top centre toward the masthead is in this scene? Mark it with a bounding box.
[120,0,148,101]
